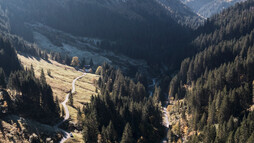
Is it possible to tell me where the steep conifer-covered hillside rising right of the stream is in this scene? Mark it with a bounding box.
[169,0,254,143]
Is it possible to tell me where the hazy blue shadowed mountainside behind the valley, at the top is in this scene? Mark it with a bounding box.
[1,0,201,70]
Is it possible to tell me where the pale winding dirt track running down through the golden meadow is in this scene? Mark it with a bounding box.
[54,73,86,143]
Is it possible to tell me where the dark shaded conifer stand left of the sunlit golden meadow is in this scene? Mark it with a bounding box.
[0,34,60,123]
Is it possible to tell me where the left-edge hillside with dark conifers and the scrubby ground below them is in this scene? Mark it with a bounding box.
[0,35,61,142]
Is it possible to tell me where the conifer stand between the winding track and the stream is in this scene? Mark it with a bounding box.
[78,64,164,143]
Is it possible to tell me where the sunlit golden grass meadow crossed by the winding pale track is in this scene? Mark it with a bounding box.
[18,55,99,142]
